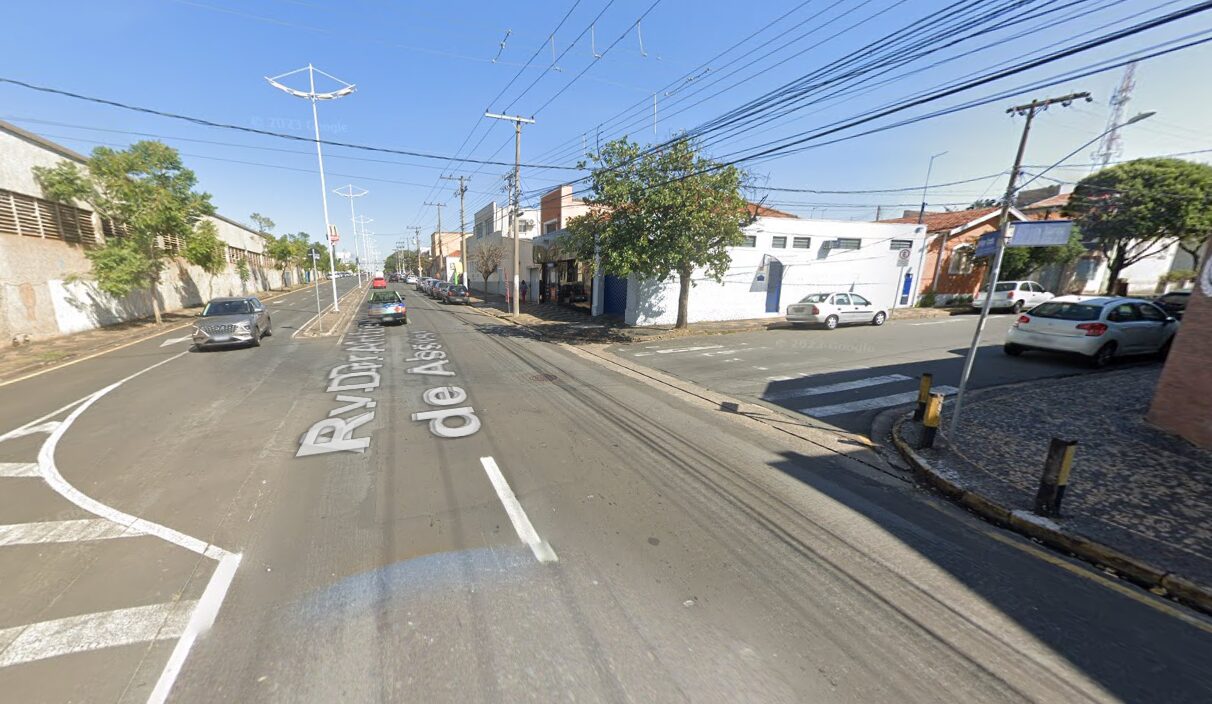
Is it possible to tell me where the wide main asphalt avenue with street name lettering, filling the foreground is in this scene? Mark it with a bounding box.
[0,282,1212,703]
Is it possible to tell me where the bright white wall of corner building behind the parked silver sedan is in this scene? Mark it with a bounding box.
[624,218,924,325]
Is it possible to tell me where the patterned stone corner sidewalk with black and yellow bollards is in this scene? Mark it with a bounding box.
[894,366,1212,609]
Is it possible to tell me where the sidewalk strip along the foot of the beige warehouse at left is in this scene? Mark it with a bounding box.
[0,286,317,383]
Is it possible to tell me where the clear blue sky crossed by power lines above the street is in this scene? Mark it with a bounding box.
[0,0,1212,255]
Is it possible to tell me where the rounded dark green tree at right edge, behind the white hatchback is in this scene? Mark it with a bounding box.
[1065,158,1212,293]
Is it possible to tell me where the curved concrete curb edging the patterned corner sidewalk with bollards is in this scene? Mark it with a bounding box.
[892,417,1212,614]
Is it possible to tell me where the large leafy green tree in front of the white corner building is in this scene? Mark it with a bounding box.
[564,137,750,327]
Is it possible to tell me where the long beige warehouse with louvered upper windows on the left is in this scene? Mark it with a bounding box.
[0,121,282,344]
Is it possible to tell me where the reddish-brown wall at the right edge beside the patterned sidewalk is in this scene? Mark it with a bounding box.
[1148,271,1212,448]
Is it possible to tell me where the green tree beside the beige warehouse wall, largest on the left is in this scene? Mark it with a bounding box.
[34,142,215,322]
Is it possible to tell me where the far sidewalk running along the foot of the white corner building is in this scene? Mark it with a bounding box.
[473,292,955,344]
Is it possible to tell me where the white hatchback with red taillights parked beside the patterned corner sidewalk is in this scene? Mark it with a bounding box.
[1002,296,1178,367]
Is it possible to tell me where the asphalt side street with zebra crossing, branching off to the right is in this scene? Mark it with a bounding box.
[610,314,1163,435]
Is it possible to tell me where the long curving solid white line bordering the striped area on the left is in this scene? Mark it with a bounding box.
[28,351,241,704]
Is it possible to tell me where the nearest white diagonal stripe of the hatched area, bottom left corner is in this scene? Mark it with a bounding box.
[0,601,195,668]
